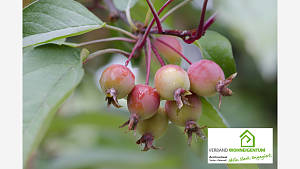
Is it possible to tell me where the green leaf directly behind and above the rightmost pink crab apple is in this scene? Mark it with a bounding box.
[195,31,236,77]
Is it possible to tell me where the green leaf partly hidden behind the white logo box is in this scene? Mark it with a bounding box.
[199,97,258,169]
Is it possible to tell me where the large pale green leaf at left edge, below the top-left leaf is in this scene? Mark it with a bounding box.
[23,44,84,161]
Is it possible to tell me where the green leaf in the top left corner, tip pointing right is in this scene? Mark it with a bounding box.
[23,0,105,47]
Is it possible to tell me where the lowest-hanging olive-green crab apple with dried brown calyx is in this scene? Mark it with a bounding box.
[136,108,168,151]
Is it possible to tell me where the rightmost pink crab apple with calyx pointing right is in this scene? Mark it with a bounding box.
[188,59,237,108]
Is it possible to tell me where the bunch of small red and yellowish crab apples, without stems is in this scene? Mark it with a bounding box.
[99,36,236,151]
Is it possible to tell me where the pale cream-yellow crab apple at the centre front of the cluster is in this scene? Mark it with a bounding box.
[154,65,191,109]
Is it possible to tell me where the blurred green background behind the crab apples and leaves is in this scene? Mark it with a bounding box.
[27,0,277,169]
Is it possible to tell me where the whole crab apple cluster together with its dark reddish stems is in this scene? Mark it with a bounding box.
[99,0,236,151]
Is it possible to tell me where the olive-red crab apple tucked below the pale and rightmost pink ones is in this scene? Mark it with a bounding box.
[165,94,205,145]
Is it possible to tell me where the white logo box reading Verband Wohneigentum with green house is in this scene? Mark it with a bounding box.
[208,128,273,164]
